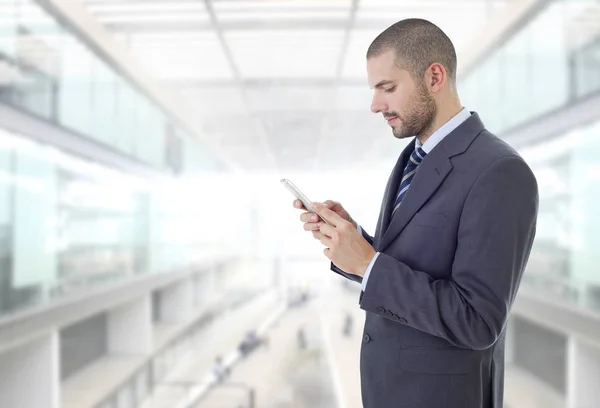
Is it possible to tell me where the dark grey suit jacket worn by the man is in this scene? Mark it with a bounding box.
[332,113,538,408]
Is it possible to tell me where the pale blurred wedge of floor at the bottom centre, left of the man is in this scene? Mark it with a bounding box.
[197,300,337,408]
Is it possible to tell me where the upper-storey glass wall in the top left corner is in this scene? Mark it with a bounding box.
[0,0,222,172]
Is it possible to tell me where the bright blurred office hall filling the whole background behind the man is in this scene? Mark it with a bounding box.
[0,0,600,408]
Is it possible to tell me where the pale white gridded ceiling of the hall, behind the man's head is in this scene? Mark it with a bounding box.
[81,0,511,172]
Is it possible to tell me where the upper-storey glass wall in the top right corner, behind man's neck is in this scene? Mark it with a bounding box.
[459,0,600,133]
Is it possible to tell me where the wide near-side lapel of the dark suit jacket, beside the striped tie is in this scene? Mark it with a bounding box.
[376,112,484,251]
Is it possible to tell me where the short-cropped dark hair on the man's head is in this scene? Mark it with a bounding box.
[367,18,456,82]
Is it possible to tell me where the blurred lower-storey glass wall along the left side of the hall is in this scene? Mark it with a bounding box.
[0,129,237,316]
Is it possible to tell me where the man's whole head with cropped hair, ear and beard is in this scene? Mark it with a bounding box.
[367,19,458,139]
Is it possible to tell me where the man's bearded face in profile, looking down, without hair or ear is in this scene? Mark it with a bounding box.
[367,51,437,139]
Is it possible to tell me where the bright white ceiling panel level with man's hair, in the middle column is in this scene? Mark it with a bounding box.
[225,30,344,78]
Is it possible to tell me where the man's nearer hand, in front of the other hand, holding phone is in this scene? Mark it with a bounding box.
[311,203,377,276]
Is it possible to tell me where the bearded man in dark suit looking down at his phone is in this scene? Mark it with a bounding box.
[294,19,538,408]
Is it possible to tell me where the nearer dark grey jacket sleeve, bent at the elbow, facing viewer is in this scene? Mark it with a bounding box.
[360,156,538,350]
